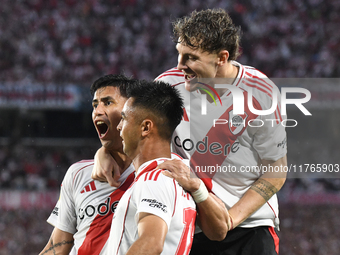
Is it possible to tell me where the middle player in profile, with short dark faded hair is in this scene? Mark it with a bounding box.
[107,81,196,255]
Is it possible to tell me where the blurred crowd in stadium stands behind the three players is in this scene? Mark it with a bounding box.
[0,0,340,255]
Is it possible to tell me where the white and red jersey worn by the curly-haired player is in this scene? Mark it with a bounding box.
[156,61,287,227]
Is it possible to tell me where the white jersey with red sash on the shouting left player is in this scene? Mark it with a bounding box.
[47,160,135,255]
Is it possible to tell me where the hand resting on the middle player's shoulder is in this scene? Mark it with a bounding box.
[157,159,201,192]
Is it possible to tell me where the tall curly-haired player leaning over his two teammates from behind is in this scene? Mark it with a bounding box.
[94,9,287,255]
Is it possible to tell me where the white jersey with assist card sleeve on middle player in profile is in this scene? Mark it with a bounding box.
[107,158,196,255]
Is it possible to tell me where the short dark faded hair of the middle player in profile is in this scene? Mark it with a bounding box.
[127,80,183,141]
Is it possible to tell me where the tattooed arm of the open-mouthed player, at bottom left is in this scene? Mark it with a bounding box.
[39,228,73,255]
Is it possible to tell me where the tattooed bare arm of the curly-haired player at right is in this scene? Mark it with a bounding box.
[229,156,287,227]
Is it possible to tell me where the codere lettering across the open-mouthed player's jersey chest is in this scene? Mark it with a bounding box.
[78,197,119,220]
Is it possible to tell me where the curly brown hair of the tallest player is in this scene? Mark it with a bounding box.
[172,9,241,60]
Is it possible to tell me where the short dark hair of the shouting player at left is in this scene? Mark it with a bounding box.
[90,74,136,98]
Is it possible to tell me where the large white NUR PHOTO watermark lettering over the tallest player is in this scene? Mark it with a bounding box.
[199,79,312,129]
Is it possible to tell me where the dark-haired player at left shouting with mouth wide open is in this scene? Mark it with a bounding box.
[40,75,135,255]
